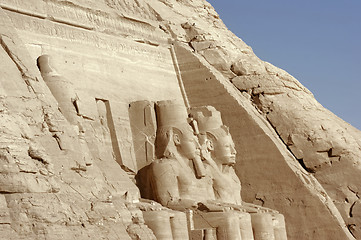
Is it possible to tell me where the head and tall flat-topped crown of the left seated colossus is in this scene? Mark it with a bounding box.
[156,101,199,159]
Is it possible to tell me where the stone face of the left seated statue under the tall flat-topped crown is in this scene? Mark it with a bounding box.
[174,126,199,159]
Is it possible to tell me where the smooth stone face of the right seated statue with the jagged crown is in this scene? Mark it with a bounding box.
[213,134,237,165]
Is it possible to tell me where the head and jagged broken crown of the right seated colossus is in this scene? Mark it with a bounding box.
[191,106,237,165]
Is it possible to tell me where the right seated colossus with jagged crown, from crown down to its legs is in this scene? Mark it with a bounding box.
[190,106,287,240]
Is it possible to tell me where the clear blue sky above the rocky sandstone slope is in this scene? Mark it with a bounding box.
[208,0,361,129]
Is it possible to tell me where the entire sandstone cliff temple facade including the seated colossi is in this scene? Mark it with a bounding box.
[0,0,361,240]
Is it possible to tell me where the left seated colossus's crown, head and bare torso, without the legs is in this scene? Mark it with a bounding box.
[152,101,214,210]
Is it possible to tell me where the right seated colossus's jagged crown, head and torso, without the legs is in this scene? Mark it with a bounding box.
[190,106,242,205]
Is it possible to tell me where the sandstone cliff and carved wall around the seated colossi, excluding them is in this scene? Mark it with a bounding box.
[0,0,361,239]
